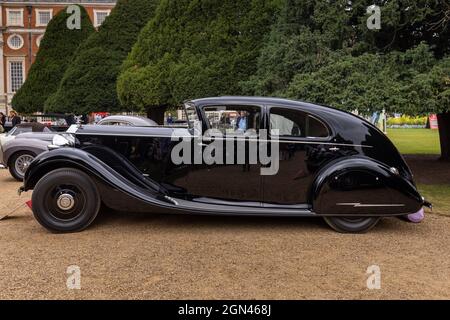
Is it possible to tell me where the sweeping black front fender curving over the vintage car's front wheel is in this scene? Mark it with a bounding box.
[19,147,178,212]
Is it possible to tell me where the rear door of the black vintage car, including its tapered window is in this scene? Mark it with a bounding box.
[263,106,336,205]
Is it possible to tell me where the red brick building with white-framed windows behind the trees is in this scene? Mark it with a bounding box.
[0,0,116,112]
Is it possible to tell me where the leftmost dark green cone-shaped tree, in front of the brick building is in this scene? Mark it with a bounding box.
[12,6,94,113]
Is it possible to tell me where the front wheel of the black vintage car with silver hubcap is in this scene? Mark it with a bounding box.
[32,168,101,232]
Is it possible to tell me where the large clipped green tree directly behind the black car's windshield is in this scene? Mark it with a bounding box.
[117,0,279,122]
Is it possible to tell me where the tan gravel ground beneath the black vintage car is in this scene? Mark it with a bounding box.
[0,170,450,299]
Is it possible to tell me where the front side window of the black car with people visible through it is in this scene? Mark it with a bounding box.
[203,106,261,135]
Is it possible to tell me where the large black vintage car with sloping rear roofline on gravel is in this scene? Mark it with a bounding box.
[21,97,430,232]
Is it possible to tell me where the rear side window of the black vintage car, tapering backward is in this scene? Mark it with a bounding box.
[270,107,329,138]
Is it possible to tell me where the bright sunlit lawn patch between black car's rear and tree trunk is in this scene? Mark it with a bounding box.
[387,129,441,154]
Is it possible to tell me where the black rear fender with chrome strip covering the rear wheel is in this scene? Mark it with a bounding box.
[309,157,425,216]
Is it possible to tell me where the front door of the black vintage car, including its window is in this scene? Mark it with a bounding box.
[185,104,262,205]
